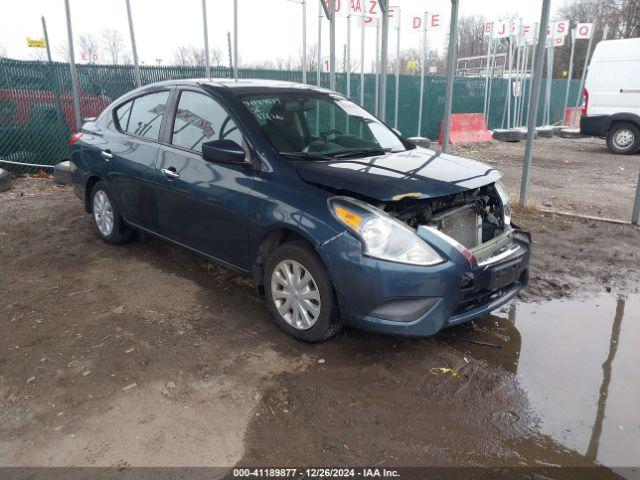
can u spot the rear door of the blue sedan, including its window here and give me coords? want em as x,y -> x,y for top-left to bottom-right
108,89 -> 171,232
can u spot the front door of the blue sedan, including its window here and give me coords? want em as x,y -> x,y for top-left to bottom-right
157,88 -> 255,270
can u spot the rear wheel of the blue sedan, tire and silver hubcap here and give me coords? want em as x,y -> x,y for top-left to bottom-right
91,182 -> 133,245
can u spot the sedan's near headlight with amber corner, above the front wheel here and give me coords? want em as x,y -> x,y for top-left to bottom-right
329,197 -> 444,265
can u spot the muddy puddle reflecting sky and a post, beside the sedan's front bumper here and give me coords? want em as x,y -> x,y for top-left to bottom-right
443,294 -> 640,467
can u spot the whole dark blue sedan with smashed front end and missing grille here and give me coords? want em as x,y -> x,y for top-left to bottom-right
71,80 -> 530,341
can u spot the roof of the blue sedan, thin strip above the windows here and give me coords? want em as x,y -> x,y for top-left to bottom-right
139,78 -> 333,94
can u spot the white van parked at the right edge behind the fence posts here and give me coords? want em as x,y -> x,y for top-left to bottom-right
580,38 -> 640,155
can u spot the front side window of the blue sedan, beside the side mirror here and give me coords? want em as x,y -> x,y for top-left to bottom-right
171,91 -> 242,152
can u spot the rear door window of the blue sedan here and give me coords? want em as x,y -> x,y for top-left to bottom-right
116,91 -> 169,140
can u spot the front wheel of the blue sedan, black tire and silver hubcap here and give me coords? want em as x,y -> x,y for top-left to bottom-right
264,242 -> 342,342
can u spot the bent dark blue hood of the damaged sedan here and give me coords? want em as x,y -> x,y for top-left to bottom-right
295,147 -> 502,201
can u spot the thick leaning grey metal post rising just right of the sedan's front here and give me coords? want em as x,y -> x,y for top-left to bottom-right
520,0 -> 551,205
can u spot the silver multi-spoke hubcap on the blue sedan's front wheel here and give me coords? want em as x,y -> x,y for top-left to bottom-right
271,260 -> 321,330
